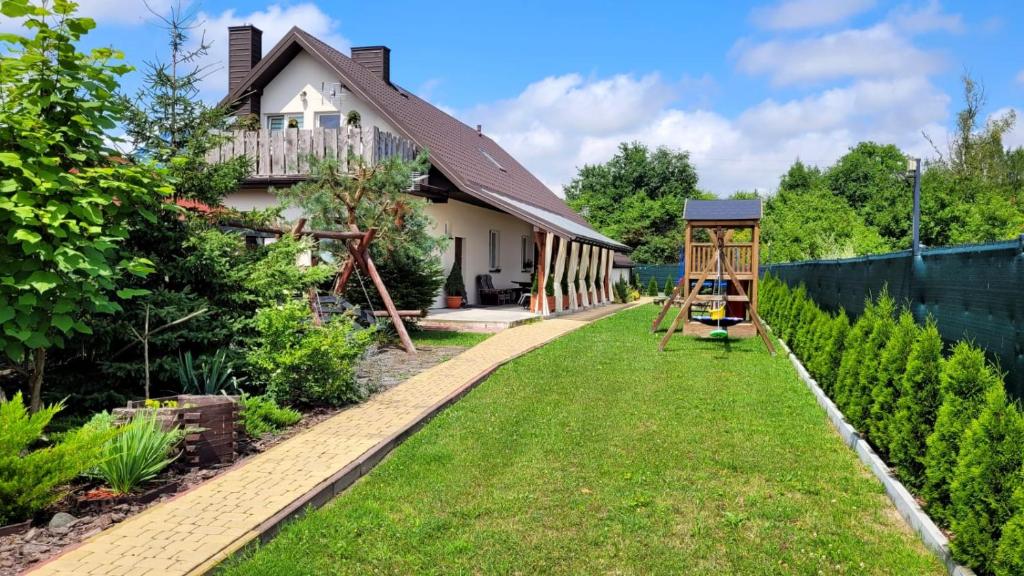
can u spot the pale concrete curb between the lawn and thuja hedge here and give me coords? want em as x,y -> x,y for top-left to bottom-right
778,340 -> 976,576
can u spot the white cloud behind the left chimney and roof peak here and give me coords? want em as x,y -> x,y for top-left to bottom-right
198,2 -> 350,101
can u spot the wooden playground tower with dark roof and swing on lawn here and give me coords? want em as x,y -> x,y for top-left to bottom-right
651,200 -> 775,355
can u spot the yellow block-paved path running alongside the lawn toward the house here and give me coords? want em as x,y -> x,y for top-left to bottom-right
30,299 -> 647,576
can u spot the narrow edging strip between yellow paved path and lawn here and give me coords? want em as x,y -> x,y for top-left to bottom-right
188,300 -> 638,576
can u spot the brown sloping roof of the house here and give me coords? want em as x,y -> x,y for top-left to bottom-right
223,28 -> 628,250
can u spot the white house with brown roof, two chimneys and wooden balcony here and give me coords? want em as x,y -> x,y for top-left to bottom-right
214,26 -> 630,315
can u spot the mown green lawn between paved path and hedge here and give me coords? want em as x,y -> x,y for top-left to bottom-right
226,305 -> 945,575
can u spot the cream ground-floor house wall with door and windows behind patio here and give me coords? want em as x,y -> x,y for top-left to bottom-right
426,200 -> 534,307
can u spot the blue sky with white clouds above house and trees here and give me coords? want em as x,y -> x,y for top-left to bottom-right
0,0 -> 1024,195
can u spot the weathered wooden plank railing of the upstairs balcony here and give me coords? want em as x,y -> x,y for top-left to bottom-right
206,126 -> 420,178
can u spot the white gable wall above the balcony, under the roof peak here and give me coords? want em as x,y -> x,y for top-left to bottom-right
260,51 -> 398,134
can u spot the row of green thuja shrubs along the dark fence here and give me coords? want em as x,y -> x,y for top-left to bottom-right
759,276 -> 1024,576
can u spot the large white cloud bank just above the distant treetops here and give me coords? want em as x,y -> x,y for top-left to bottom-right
460,69 -> 949,196
